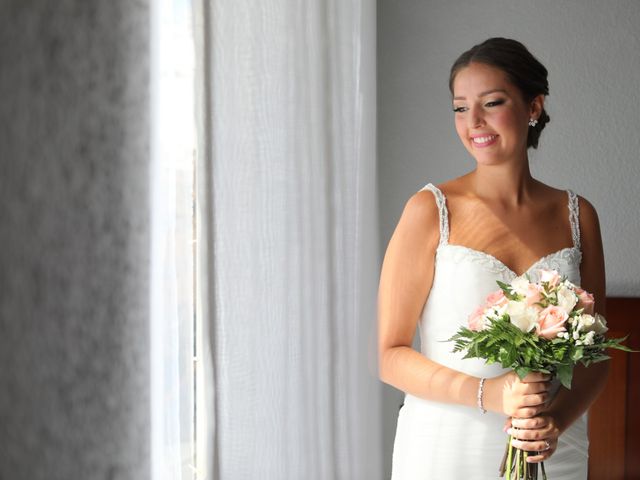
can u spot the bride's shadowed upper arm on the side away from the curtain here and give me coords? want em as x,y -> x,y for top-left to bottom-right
578,197 -> 606,315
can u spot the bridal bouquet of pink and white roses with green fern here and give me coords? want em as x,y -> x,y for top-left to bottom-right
449,270 -> 632,480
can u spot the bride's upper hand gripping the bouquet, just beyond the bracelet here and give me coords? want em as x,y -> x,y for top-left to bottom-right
484,372 -> 551,418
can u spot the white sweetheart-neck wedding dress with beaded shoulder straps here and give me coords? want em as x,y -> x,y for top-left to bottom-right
391,183 -> 588,480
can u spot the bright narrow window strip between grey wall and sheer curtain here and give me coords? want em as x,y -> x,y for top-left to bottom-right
151,0 -> 207,480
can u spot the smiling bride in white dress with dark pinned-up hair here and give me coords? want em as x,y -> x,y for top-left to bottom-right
378,38 -> 608,480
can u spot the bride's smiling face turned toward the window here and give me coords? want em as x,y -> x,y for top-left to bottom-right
453,62 -> 543,165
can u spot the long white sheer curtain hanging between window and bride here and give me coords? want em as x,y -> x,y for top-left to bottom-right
200,0 -> 382,480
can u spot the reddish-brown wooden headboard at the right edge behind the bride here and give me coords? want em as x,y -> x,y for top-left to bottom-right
589,297 -> 640,480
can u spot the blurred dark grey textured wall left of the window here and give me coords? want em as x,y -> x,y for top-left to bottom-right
0,0 -> 149,480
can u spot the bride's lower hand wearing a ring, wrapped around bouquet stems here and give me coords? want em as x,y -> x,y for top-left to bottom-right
505,415 -> 560,463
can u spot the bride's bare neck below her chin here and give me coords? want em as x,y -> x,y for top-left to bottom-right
471,156 -> 534,207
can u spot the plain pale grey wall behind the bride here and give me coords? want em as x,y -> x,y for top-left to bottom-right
378,0 -> 640,476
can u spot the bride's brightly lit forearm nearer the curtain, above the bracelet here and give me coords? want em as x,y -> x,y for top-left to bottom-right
380,346 -> 478,407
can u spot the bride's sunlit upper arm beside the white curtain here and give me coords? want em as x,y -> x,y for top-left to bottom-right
378,191 -> 440,358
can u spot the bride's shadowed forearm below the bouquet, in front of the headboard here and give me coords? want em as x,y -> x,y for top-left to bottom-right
547,361 -> 609,433
